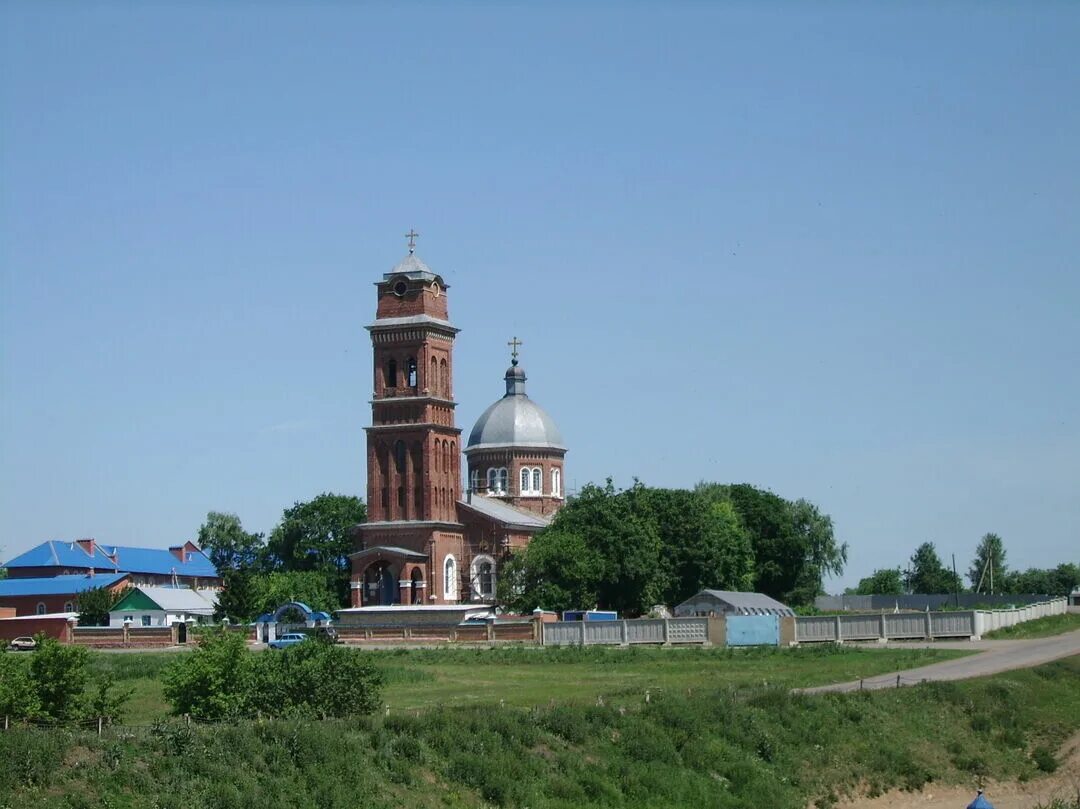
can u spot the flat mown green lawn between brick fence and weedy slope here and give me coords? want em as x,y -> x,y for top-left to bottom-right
91,646 -> 968,724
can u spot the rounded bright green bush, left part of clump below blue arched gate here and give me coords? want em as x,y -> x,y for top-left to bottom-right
162,629 -> 254,719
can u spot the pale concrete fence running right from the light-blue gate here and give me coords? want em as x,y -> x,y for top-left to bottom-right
795,598 -> 1068,644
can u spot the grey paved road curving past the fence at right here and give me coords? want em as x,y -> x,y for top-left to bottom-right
799,631 -> 1080,693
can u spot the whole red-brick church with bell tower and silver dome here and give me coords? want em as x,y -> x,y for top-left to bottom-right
351,238 -> 566,607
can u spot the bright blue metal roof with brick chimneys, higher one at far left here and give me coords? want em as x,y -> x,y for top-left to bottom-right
4,539 -> 217,577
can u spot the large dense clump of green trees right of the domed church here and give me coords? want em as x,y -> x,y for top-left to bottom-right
500,481 -> 829,615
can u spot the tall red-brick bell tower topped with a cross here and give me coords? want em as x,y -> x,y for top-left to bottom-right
351,231 -> 463,607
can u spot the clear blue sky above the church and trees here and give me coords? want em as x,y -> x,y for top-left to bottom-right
0,1 -> 1080,591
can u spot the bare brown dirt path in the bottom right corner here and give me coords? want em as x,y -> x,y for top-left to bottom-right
837,732 -> 1080,809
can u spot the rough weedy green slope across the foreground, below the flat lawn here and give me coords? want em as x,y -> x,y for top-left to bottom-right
0,650 -> 1080,809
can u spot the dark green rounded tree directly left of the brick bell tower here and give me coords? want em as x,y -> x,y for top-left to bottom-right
267,494 -> 367,607
